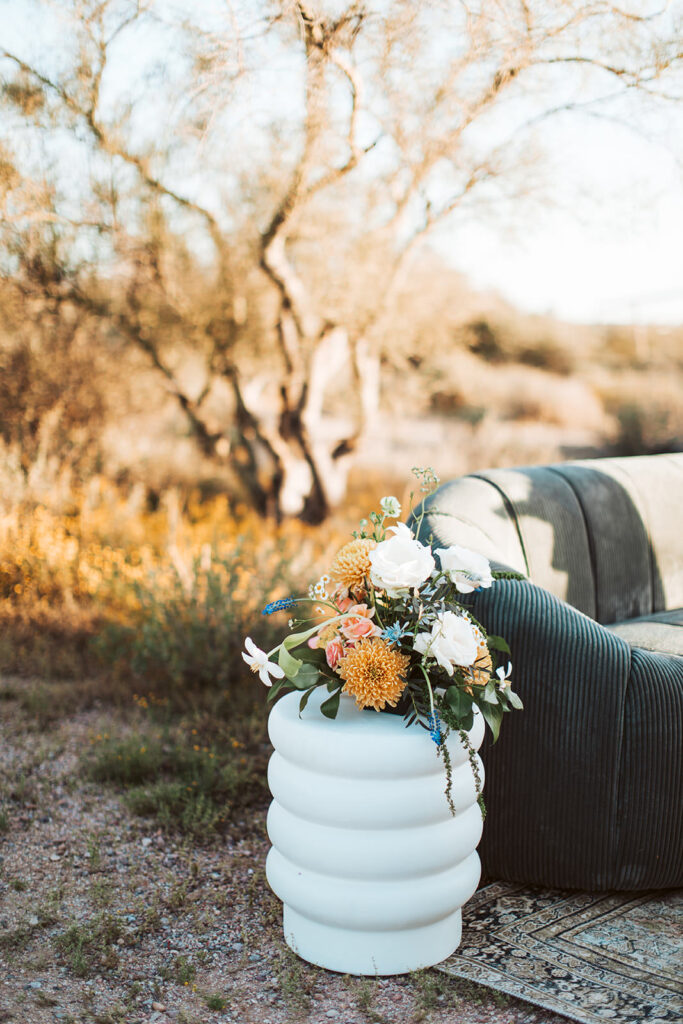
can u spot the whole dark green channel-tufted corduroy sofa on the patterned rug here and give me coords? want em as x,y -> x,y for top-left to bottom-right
413,454 -> 683,890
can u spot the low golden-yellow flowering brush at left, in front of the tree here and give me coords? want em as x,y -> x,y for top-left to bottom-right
0,481 -> 329,699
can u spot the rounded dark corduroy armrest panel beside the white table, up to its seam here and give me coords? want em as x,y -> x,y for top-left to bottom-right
471,580 -> 631,889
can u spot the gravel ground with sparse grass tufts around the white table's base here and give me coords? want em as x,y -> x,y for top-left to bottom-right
0,681 -> 565,1024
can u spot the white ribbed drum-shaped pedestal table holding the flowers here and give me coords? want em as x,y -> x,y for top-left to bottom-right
266,687 -> 484,975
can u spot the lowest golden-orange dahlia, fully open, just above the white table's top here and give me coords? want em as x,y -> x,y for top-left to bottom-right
337,637 -> 411,711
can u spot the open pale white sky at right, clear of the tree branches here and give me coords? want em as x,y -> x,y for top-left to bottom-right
437,111 -> 683,325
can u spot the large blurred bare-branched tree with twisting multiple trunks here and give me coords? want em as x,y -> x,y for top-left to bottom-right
0,0 -> 683,521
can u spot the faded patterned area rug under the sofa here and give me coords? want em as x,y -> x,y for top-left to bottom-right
439,882 -> 683,1024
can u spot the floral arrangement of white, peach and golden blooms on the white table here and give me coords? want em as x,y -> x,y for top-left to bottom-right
243,469 -> 522,813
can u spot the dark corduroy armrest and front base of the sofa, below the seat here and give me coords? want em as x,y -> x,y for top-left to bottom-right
468,580 -> 683,890
